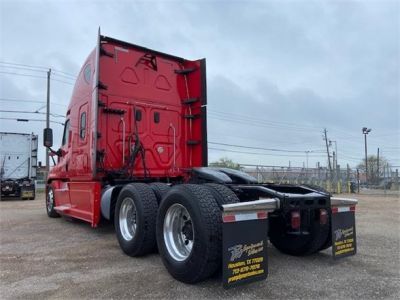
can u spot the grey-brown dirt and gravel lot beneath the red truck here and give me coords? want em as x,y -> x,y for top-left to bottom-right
0,195 -> 400,299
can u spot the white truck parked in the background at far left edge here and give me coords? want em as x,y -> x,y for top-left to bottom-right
0,132 -> 38,200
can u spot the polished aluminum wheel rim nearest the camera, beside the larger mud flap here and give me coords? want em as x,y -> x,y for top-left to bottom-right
163,203 -> 194,261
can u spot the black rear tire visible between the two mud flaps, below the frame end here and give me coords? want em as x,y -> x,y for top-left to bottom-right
269,210 -> 330,256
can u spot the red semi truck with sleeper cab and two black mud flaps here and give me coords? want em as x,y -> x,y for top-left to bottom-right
44,33 -> 356,287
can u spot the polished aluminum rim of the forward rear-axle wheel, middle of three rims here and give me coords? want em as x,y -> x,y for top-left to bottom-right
119,197 -> 137,241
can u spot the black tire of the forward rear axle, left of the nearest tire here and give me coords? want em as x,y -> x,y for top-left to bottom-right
114,183 -> 158,256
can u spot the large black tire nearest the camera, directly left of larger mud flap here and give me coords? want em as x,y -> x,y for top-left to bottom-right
157,184 -> 222,283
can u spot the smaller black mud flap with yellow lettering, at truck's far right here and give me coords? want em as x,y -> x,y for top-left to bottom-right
331,206 -> 357,259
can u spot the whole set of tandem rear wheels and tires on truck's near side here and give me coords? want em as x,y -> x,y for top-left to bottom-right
114,183 -> 239,283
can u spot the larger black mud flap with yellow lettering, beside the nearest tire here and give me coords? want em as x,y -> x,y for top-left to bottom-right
222,211 -> 268,288
